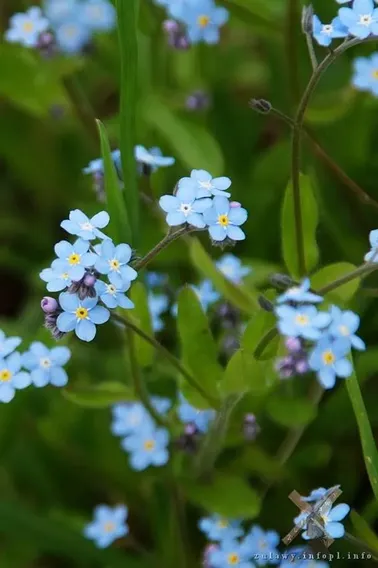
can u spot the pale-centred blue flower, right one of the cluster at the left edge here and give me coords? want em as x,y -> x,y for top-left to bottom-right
22,341 -> 71,387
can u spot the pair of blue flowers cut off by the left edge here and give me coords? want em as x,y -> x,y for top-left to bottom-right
0,330 -> 71,402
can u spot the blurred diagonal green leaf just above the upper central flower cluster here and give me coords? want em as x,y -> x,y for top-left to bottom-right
142,96 -> 224,176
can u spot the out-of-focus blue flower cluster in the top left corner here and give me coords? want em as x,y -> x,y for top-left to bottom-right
5,0 -> 116,53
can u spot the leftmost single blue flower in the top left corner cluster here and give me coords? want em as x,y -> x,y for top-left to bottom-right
5,6 -> 49,47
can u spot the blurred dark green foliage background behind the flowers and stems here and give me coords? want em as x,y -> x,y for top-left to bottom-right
0,0 -> 378,568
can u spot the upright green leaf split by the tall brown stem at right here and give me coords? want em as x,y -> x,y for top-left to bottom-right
281,174 -> 319,278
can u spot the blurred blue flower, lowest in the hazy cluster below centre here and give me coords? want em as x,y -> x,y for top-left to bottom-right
121,422 -> 169,471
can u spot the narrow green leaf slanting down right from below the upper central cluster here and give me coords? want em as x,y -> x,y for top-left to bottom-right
189,238 -> 258,314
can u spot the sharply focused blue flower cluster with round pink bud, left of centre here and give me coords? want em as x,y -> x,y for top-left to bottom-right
40,209 -> 137,341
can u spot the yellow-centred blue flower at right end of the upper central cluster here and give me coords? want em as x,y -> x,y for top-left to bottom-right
203,196 -> 248,241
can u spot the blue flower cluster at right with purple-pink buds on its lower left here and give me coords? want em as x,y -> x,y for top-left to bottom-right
275,279 -> 365,389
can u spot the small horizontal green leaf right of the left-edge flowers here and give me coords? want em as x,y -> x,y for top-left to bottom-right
62,382 -> 135,408
